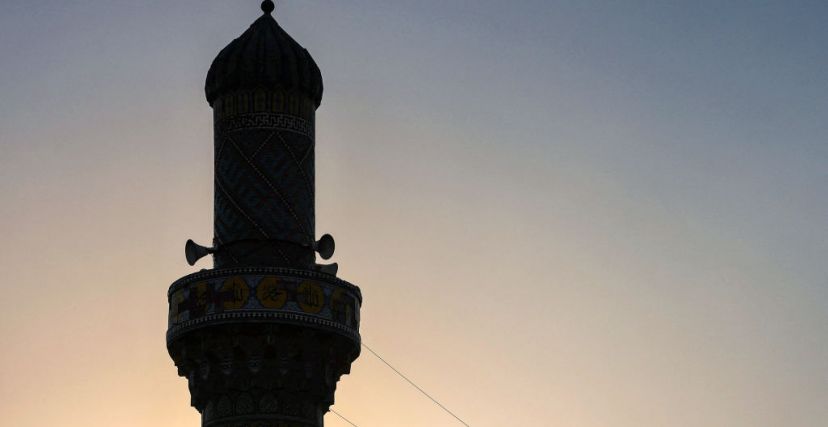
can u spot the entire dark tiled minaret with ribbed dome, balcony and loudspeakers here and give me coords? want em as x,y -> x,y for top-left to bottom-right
167,0 -> 362,427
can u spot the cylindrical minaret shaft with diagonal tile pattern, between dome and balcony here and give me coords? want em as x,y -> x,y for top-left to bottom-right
214,112 -> 315,267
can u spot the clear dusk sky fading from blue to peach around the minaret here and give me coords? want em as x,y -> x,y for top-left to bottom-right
0,0 -> 828,427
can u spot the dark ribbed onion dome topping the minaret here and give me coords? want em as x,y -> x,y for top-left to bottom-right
205,11 -> 322,107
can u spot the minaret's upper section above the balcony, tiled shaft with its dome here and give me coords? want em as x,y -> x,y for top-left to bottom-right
206,0 -> 322,268
